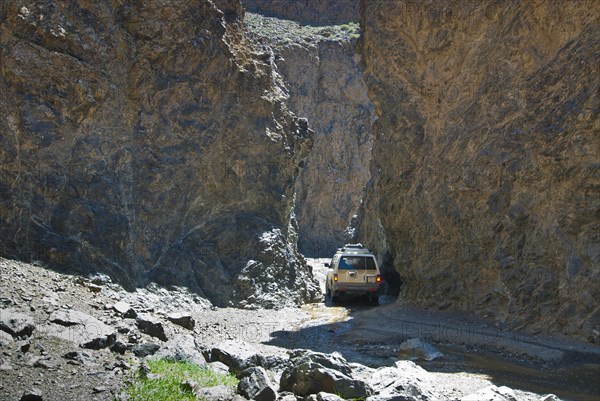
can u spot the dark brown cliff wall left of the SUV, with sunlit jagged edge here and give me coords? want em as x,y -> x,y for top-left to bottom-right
0,0 -> 317,305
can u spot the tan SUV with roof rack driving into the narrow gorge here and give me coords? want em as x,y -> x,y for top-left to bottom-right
325,244 -> 381,303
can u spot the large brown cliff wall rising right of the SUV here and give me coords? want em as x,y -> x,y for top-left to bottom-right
360,0 -> 600,341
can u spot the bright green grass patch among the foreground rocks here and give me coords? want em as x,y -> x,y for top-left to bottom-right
126,359 -> 238,401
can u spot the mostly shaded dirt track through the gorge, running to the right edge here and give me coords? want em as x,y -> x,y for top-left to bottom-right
298,259 -> 600,401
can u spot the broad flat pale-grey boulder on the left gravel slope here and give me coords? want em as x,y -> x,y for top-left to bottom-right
47,310 -> 117,349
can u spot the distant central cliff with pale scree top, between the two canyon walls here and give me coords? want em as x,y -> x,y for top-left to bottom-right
244,13 -> 373,257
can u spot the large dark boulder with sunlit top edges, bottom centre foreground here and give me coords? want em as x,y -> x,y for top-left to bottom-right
280,350 -> 372,398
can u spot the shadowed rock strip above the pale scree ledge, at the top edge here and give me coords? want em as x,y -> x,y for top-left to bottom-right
241,0 -> 360,25
